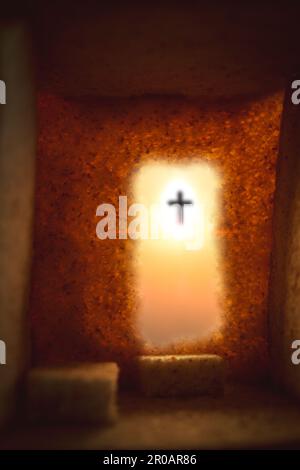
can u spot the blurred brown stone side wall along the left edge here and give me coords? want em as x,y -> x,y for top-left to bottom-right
0,24 -> 35,426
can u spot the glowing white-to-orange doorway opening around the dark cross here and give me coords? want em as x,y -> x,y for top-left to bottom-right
135,163 -> 221,346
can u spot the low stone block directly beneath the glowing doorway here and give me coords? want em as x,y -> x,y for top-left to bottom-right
138,354 -> 225,397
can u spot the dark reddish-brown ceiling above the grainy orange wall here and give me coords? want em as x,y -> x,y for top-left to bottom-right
1,1 -> 300,99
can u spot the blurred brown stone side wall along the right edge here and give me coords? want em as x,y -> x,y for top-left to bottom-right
269,84 -> 300,397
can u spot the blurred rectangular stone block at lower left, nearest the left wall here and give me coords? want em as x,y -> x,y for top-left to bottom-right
27,363 -> 118,424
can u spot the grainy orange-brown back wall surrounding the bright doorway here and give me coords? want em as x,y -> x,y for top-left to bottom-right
31,93 -> 282,380
